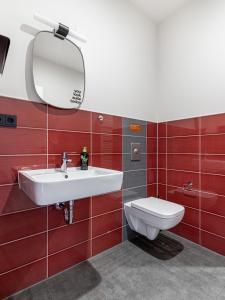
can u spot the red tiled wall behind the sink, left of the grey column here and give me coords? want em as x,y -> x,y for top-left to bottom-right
0,97 -> 125,299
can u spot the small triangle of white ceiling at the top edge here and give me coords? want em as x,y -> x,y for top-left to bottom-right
130,0 -> 190,22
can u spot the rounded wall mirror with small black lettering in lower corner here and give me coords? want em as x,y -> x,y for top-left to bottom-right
33,31 -> 85,109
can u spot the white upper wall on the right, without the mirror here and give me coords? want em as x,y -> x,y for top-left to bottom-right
158,0 -> 225,121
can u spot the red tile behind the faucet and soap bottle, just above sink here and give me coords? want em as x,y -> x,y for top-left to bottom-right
48,154 -> 81,168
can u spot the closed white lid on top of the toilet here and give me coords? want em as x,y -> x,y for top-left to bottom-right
131,197 -> 184,219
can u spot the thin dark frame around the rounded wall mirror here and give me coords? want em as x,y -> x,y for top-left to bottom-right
31,30 -> 86,110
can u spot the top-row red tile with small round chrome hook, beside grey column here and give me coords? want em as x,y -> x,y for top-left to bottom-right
92,113 -> 122,135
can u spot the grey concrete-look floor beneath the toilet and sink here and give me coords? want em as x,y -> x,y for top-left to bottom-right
9,233 -> 225,300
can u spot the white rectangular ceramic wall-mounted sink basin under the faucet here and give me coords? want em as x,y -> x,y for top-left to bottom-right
19,167 -> 123,206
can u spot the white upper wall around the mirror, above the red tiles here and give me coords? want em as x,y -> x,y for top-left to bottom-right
0,0 -> 156,121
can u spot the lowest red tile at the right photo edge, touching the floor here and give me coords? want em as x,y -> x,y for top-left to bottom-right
201,231 -> 225,255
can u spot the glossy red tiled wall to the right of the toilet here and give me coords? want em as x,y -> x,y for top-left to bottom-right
158,114 -> 225,255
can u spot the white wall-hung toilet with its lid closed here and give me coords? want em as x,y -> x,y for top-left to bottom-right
124,197 -> 185,240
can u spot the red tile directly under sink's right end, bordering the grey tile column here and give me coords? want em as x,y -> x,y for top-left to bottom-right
92,191 -> 122,216
